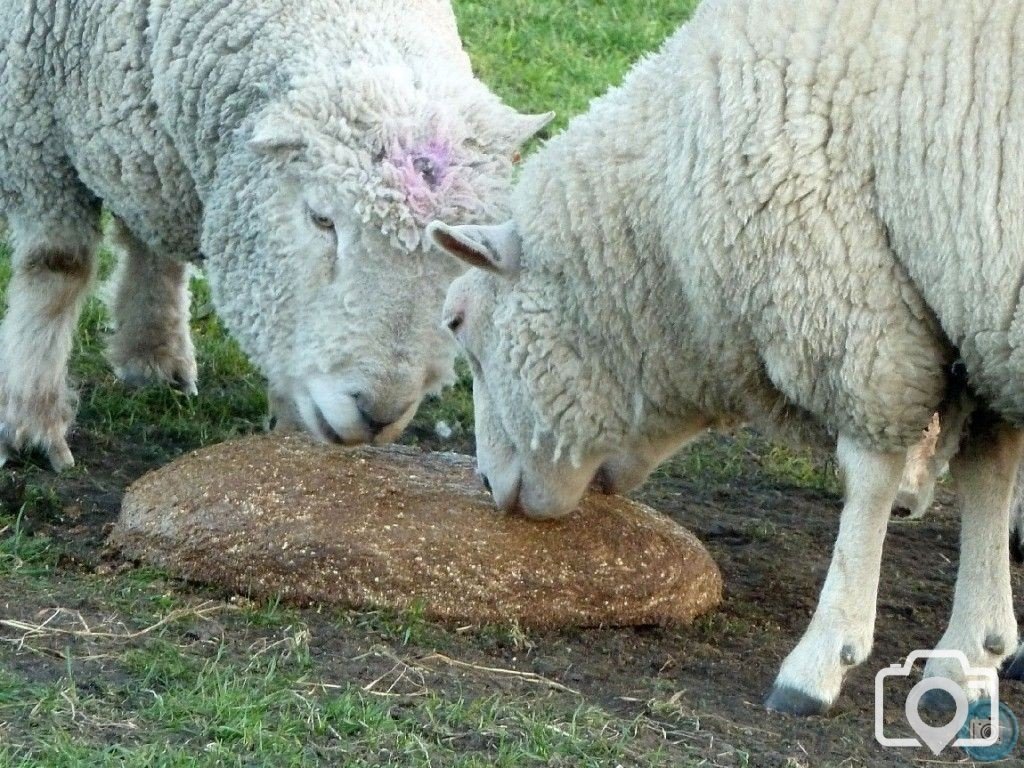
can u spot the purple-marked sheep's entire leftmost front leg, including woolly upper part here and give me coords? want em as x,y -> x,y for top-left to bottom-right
0,175 -> 99,471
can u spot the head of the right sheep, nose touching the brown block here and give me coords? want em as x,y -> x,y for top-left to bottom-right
427,222 -> 708,517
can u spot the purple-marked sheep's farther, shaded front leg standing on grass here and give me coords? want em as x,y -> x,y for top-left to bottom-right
106,218 -> 197,394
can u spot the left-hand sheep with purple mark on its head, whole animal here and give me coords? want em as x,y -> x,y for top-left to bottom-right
0,0 -> 551,469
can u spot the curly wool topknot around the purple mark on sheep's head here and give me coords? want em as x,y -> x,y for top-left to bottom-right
264,61 -> 513,251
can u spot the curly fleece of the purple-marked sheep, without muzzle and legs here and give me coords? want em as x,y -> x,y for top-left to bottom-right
0,0 -> 524,388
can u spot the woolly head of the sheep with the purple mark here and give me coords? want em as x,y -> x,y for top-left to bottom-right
204,65 -> 550,444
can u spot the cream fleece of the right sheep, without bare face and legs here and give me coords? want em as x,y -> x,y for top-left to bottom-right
489,0 -> 1024,462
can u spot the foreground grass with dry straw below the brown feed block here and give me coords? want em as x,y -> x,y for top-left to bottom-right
0,501 -> 700,768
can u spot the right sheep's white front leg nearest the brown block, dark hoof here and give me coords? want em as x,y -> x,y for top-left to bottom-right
766,436 -> 905,715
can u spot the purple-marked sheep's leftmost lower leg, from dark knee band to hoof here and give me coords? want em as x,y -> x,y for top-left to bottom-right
0,237 -> 95,471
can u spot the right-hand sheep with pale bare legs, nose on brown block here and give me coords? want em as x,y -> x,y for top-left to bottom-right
427,0 -> 1024,715
